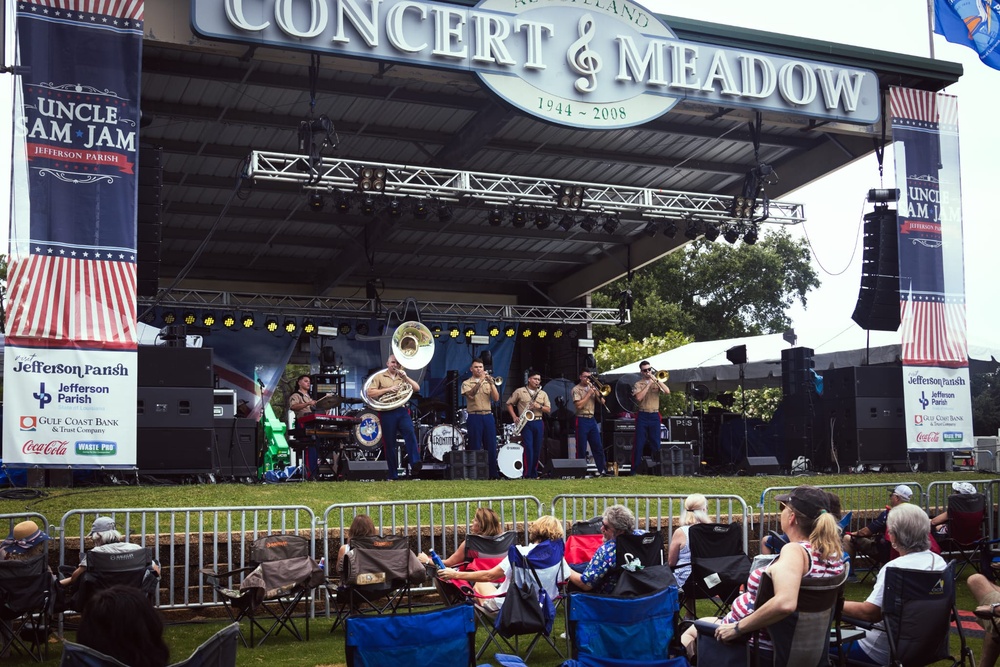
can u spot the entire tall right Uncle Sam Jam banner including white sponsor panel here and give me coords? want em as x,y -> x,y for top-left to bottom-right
889,87 -> 972,450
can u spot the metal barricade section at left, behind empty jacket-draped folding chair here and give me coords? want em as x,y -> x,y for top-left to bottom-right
58,505 -> 317,609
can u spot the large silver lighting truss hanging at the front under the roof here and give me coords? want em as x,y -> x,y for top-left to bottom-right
244,151 -> 805,225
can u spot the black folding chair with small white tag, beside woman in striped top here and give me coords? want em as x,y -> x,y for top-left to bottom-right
682,523 -> 750,617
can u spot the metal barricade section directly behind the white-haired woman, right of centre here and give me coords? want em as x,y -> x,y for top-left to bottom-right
551,494 -> 753,550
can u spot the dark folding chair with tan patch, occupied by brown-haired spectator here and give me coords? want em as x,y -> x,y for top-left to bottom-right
330,535 -> 426,632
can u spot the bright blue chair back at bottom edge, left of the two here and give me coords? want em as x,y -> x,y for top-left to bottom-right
344,605 -> 476,667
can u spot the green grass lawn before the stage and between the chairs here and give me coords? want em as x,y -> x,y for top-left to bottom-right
0,473 -> 983,667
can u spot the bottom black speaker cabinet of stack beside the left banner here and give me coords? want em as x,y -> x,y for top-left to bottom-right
136,428 -> 215,475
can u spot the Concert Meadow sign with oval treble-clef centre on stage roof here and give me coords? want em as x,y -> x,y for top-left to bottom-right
191,0 -> 880,130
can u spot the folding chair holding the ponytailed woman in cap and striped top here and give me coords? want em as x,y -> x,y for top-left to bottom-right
695,569 -> 847,667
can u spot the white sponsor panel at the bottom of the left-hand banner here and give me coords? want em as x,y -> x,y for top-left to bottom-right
3,338 -> 137,468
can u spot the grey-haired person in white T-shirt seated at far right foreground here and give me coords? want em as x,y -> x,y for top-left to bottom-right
843,503 -> 946,665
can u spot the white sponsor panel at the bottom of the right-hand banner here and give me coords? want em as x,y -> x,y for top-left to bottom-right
903,367 -> 975,450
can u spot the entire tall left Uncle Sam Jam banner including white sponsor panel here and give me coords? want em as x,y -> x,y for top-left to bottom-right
3,0 -> 143,467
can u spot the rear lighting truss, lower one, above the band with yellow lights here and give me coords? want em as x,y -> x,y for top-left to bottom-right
139,289 -> 621,326
